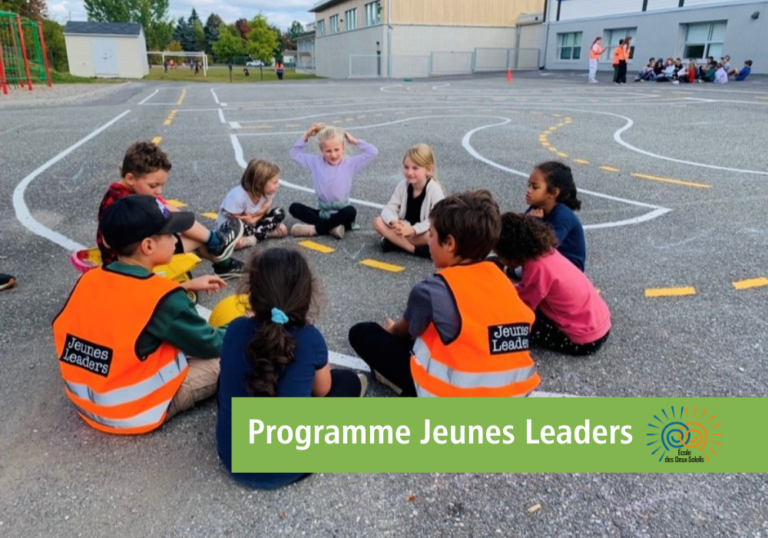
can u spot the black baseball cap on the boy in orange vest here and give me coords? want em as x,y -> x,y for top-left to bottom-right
100,194 -> 195,248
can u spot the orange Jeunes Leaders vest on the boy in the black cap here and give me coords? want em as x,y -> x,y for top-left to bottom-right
53,268 -> 187,434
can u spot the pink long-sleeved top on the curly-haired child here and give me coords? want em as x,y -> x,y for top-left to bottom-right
515,250 -> 611,344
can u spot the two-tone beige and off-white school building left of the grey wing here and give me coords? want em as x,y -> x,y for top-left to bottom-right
310,0 -> 544,78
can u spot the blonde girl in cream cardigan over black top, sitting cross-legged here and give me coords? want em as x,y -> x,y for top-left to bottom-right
373,144 -> 445,258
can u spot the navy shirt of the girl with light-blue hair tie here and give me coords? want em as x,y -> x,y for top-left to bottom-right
216,317 -> 328,489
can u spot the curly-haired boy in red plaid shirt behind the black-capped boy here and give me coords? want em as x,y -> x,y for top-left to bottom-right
96,142 -> 243,279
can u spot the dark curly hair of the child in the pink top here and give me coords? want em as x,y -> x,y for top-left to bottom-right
495,212 -> 557,265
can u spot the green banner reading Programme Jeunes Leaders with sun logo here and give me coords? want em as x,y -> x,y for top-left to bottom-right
232,398 -> 768,473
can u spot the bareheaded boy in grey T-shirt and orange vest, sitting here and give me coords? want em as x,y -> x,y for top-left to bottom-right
349,190 -> 541,397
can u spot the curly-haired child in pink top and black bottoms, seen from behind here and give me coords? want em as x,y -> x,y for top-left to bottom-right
495,213 -> 611,355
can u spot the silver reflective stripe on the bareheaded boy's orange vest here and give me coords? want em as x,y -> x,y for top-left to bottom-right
413,338 -> 536,390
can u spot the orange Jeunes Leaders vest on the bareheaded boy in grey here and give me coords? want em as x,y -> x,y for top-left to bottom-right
411,261 -> 541,397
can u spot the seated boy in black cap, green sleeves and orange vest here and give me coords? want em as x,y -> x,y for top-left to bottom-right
53,194 -> 226,434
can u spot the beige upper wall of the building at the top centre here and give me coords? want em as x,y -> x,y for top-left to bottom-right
396,0 -> 544,26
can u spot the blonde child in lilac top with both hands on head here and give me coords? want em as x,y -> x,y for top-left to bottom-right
288,123 -> 379,239
